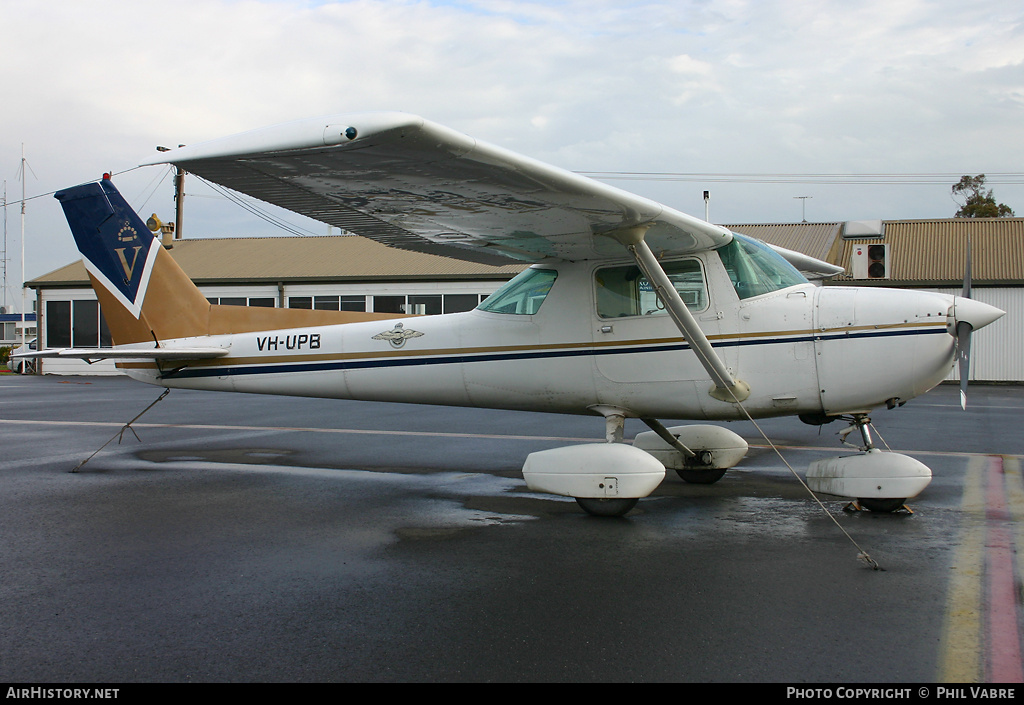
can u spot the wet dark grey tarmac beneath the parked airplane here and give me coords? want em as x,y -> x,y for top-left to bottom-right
0,376 -> 1024,683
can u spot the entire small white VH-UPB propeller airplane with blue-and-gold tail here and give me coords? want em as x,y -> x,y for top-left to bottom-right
34,113 -> 1004,515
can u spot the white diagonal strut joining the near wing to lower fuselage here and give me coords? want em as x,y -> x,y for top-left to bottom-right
610,225 -> 751,403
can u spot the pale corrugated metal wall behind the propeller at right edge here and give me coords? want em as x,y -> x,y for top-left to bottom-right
929,287 -> 1024,382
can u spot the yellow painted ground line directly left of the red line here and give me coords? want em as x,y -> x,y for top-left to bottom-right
937,457 -> 988,683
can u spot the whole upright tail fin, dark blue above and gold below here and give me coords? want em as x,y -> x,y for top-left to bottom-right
54,177 -> 210,345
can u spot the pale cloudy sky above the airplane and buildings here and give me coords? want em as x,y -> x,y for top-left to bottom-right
0,0 -> 1024,296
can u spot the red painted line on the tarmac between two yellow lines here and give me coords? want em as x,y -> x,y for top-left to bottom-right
986,456 -> 1024,682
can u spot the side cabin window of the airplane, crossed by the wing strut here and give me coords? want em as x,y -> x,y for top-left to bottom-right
594,259 -> 708,319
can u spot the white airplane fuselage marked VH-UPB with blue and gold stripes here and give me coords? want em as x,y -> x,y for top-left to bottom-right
130,251 -> 955,419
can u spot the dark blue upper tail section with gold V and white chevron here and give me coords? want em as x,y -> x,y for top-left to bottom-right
54,178 -> 161,319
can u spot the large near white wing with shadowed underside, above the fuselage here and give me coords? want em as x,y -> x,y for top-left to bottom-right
145,113 -> 732,264
